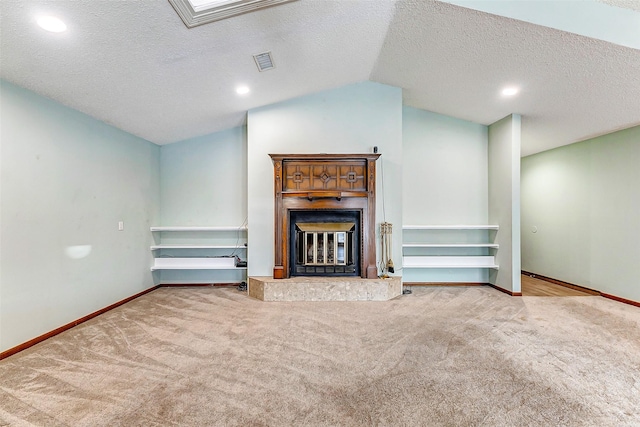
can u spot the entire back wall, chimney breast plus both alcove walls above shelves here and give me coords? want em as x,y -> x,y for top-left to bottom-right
161,83 -> 488,282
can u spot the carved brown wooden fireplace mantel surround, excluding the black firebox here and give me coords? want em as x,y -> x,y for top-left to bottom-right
269,154 -> 380,279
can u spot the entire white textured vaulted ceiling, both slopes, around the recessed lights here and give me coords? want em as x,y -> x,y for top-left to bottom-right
0,0 -> 640,155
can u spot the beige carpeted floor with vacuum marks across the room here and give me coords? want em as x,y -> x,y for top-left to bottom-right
0,287 -> 640,427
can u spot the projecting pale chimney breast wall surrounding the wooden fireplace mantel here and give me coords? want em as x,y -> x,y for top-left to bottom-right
247,82 -> 403,276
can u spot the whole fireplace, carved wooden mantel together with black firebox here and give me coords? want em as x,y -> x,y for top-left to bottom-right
270,154 -> 380,279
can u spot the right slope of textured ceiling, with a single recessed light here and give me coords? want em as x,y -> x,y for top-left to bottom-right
372,1 -> 640,154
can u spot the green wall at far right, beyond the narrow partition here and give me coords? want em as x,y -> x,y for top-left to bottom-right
522,126 -> 640,301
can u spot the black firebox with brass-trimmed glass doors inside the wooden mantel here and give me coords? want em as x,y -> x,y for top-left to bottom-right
288,210 -> 360,276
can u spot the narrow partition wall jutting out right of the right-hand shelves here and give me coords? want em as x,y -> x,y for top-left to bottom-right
489,114 -> 522,293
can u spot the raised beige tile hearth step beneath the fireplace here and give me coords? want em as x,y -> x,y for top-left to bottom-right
249,277 -> 402,301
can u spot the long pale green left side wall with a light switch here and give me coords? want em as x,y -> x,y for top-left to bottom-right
0,82 -> 160,351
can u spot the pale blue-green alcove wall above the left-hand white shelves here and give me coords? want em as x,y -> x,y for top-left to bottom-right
157,126 -> 247,226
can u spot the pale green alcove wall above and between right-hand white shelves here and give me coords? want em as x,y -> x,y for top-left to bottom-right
402,106 -> 492,283
